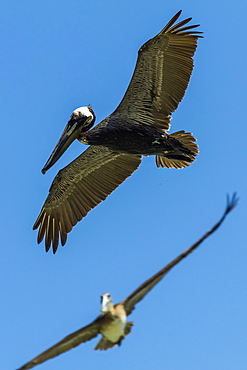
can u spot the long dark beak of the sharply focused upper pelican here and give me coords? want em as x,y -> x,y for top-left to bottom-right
41,114 -> 90,174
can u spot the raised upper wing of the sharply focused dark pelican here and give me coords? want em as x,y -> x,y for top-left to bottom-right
112,11 -> 202,130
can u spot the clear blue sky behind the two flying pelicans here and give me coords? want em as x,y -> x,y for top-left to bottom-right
0,0 -> 247,370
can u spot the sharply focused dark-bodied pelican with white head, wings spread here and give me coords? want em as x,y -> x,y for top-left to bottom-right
33,10 -> 202,253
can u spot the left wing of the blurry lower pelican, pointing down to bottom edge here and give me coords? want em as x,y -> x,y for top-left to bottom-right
18,316 -> 101,370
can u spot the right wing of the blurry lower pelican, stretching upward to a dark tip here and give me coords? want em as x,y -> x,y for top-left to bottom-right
121,193 -> 238,315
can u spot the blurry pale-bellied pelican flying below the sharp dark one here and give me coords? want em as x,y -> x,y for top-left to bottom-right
18,193 -> 238,370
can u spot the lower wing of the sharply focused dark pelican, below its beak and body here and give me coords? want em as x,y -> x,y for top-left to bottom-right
33,146 -> 141,253
